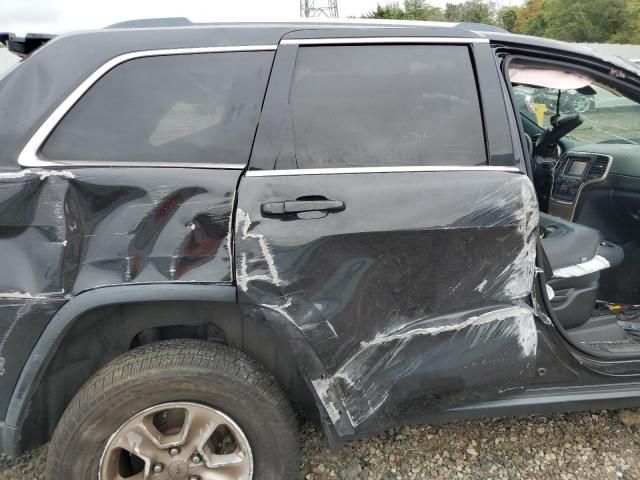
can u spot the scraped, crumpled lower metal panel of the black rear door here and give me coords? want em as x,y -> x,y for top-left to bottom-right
236,173 -> 538,429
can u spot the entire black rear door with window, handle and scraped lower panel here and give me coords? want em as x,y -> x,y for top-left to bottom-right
235,37 -> 538,435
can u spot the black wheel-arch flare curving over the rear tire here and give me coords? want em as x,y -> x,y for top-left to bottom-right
0,283 -> 236,455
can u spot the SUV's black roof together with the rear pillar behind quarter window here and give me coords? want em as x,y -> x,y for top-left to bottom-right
0,19 -> 640,170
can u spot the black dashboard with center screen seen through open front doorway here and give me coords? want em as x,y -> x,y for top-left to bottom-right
541,142 -> 640,304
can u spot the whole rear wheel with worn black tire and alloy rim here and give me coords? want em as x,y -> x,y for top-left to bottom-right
47,340 -> 299,480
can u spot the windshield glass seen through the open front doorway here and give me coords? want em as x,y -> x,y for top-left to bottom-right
513,82 -> 640,144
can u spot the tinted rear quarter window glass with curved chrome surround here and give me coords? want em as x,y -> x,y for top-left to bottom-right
41,52 -> 273,164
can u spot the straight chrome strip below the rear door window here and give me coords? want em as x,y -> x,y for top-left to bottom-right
246,165 -> 523,177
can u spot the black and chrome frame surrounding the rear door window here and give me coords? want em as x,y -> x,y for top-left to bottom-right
247,36 -> 496,175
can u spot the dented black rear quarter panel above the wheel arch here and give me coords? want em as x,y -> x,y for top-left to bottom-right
0,168 -> 240,414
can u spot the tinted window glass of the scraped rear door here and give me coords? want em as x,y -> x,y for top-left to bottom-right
289,45 -> 486,168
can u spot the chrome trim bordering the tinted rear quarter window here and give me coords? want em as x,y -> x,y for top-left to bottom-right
18,45 -> 277,169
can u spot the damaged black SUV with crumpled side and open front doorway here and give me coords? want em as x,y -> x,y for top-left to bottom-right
0,22 -> 640,480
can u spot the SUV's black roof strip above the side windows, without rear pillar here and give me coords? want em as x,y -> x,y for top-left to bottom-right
0,17 -> 636,66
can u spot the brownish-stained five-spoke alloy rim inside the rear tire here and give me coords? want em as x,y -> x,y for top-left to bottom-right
99,402 -> 253,480
